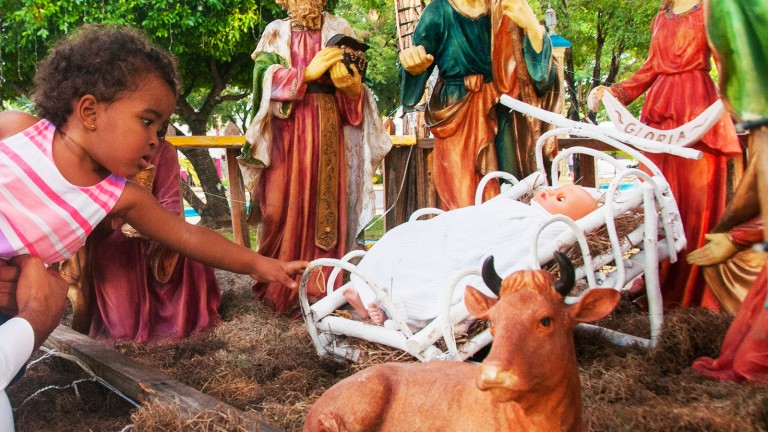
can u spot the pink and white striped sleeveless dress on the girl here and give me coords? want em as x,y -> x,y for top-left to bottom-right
0,120 -> 126,264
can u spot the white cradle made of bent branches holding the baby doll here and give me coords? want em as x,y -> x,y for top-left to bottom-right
299,98 -> 696,361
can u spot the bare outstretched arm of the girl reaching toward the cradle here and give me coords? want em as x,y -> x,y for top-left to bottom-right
111,181 -> 307,288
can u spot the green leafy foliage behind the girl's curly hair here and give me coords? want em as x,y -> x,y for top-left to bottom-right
0,0 -> 282,113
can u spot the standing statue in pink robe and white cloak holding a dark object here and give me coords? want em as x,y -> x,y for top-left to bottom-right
240,0 -> 392,314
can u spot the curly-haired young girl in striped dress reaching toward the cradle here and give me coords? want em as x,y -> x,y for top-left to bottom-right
0,25 -> 306,287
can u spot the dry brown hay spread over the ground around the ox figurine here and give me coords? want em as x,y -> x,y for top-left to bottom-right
9,272 -> 768,432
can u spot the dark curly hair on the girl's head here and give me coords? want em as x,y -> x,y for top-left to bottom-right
32,24 -> 180,127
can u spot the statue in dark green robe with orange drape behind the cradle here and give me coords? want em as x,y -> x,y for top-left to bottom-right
400,0 -> 560,209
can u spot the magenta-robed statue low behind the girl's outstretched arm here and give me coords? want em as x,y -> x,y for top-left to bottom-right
83,140 -> 221,343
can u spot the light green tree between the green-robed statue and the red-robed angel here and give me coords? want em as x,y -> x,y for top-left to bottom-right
552,0 -> 659,120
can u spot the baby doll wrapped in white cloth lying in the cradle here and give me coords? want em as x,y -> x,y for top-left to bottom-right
342,184 -> 598,328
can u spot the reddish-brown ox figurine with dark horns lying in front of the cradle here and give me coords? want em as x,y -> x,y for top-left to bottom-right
304,252 -> 619,432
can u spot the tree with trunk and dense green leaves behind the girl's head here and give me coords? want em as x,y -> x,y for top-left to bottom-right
0,0 -> 282,226
